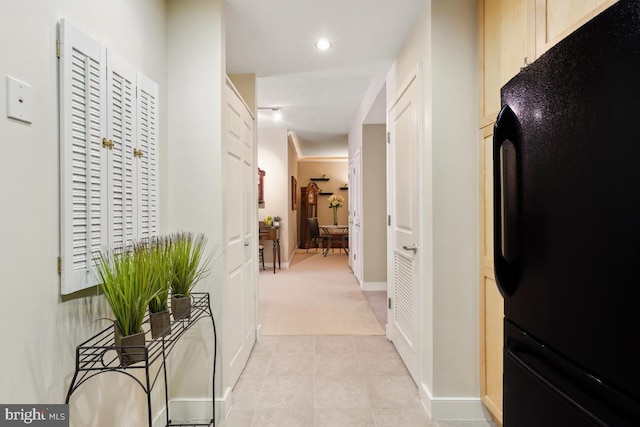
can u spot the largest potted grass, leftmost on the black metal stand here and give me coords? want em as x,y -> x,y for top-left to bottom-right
96,248 -> 156,366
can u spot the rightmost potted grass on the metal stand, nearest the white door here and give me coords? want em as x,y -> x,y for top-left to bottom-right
169,232 -> 214,320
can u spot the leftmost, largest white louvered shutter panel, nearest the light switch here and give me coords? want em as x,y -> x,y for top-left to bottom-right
59,20 -> 108,294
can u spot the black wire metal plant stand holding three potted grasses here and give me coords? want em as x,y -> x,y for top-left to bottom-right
65,292 -> 218,427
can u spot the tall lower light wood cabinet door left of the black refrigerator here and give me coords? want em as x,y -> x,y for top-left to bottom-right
479,125 -> 504,424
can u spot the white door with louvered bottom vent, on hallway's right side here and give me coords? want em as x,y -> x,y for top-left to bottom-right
387,74 -> 420,382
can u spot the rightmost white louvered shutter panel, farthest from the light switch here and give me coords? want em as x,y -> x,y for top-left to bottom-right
135,73 -> 158,239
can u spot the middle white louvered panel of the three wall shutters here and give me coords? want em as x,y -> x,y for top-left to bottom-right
107,55 -> 137,251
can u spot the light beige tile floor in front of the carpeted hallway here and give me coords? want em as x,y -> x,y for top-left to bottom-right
218,336 -> 495,427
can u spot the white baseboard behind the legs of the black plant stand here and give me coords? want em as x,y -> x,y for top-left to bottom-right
166,387 -> 232,427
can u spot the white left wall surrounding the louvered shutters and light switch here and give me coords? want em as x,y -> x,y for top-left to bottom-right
0,0 -> 167,427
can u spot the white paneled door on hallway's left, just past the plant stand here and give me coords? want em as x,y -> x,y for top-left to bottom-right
222,82 -> 258,384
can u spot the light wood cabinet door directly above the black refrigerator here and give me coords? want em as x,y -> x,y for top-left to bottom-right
535,0 -> 617,58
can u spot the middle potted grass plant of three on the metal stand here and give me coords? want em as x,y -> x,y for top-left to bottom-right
145,237 -> 171,338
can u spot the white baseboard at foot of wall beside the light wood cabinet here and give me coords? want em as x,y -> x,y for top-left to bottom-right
420,383 -> 491,427
